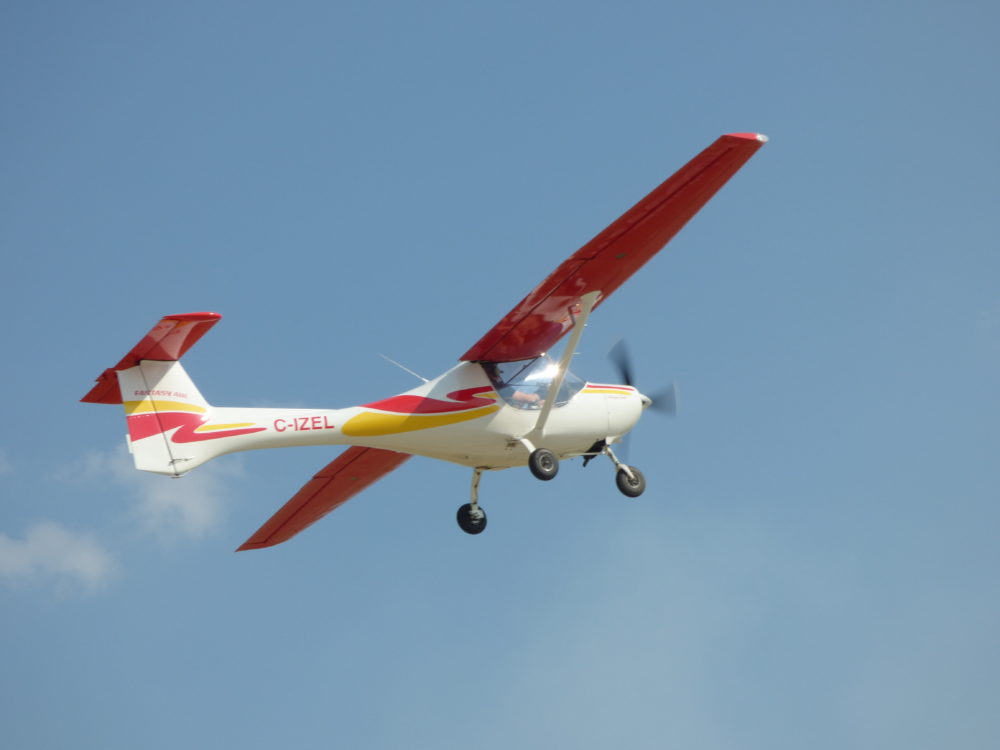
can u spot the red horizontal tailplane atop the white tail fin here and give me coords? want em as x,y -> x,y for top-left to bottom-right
80,313 -> 222,404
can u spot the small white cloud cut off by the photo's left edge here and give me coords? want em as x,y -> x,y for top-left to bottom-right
0,521 -> 118,592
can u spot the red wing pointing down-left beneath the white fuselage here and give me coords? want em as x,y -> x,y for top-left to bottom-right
239,448 -> 410,550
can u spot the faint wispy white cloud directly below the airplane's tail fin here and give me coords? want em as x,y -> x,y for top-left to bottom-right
76,447 -> 243,541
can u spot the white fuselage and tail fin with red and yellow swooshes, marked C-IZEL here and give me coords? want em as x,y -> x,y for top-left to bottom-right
120,361 -> 643,475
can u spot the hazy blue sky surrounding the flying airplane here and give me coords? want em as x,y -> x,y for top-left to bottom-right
0,0 -> 1000,750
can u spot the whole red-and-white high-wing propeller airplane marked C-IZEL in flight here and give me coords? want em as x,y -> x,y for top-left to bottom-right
81,133 -> 767,550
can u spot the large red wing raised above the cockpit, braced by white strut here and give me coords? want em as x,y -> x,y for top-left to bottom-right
461,133 -> 767,362
